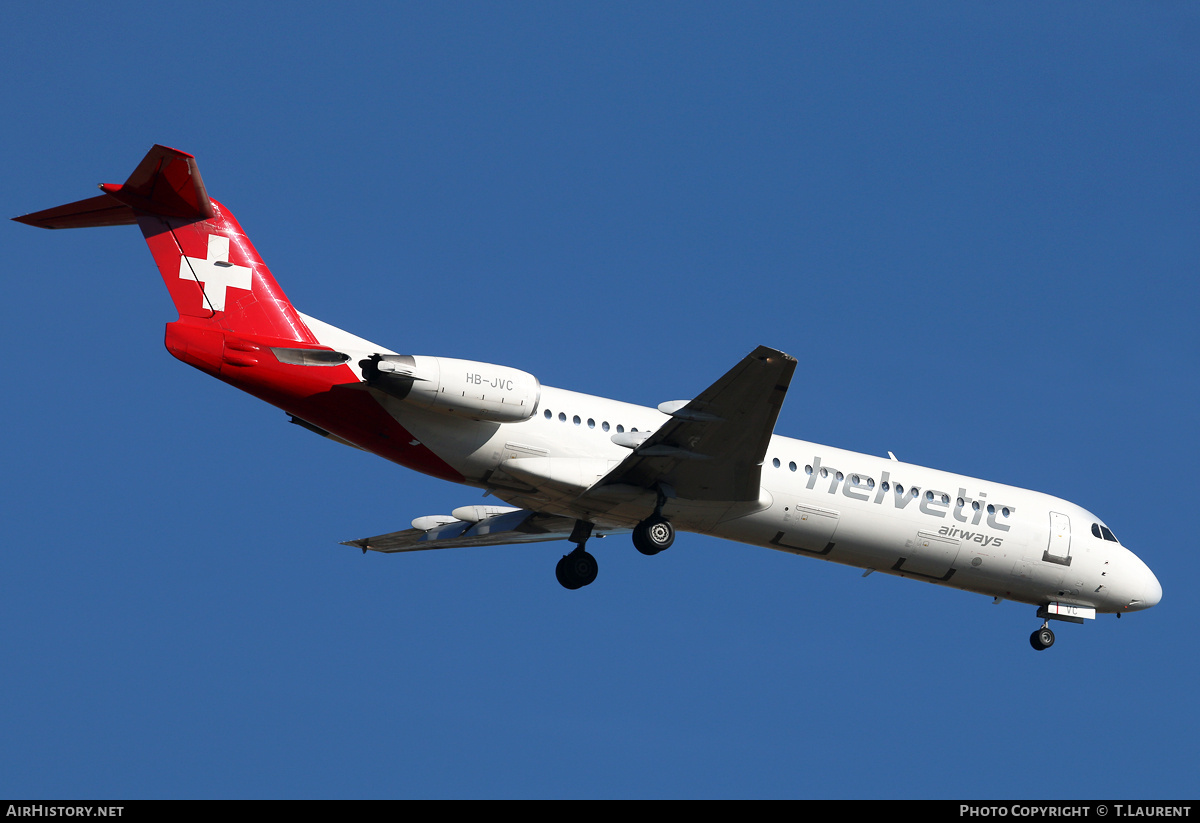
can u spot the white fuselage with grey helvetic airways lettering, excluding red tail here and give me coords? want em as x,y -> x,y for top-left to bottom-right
350,364 -> 1160,612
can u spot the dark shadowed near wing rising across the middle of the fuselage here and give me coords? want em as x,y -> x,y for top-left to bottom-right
588,346 -> 796,500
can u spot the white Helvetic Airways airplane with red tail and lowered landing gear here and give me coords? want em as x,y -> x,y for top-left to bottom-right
13,145 -> 1163,650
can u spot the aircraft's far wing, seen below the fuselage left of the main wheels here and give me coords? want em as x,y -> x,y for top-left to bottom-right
342,509 -> 630,553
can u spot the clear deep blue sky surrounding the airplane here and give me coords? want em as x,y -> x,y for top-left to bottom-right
0,2 -> 1200,799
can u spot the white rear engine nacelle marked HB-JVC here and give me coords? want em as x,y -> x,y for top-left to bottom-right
361,354 -> 541,423
